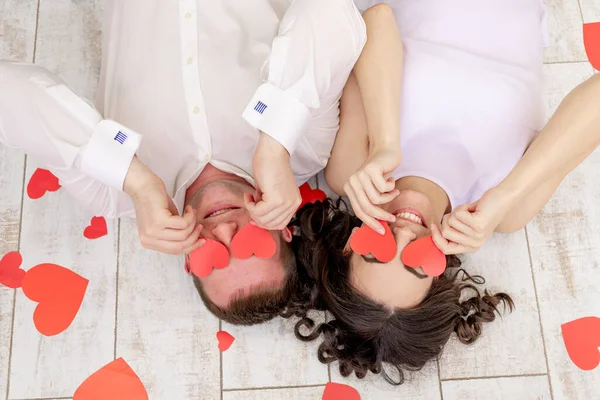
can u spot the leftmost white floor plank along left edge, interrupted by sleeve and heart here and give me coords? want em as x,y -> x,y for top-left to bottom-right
0,0 -> 37,398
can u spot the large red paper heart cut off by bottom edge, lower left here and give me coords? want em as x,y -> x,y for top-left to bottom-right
73,358 -> 148,400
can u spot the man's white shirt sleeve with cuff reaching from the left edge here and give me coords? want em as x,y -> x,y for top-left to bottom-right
0,62 -> 142,216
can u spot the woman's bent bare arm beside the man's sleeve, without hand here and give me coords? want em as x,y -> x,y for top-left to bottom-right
325,4 -> 403,191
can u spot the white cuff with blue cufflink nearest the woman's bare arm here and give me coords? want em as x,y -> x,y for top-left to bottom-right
242,83 -> 310,155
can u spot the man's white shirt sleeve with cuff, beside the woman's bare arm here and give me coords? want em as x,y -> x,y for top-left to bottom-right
243,0 -> 366,155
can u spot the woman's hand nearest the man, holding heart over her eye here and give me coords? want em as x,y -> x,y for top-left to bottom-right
344,145 -> 402,235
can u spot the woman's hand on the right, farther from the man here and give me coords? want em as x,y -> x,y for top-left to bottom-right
431,187 -> 511,254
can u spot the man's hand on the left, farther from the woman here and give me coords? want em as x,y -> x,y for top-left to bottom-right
123,157 -> 204,254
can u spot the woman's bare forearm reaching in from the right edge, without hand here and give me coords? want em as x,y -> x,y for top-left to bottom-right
496,74 -> 600,232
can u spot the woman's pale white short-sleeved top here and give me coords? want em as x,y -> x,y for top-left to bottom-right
357,0 -> 547,207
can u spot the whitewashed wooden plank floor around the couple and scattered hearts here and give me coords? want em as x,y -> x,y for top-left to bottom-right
0,0 -> 600,400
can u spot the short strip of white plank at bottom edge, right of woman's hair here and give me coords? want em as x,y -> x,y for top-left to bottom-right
442,375 -> 558,400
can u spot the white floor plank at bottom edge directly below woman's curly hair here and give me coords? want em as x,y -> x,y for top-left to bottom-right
331,361 -> 441,400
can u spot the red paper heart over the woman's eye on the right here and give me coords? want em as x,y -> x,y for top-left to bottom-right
402,236 -> 446,276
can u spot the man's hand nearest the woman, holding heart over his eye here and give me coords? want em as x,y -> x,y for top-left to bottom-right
244,132 -> 302,230
